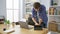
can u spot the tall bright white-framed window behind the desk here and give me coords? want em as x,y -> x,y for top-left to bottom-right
6,0 -> 19,22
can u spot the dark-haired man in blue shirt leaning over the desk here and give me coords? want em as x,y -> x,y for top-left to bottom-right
32,2 -> 48,28
